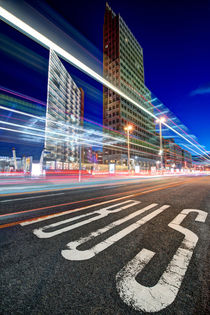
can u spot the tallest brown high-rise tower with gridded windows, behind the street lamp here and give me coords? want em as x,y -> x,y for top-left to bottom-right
103,4 -> 158,170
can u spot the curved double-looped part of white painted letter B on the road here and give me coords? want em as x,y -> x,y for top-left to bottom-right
33,200 -> 140,238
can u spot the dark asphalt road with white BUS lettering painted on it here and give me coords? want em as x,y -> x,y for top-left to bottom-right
0,176 -> 210,315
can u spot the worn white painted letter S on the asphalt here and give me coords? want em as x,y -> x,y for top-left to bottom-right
116,209 -> 207,312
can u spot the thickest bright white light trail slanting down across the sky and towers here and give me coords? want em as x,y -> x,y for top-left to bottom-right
0,6 -> 209,160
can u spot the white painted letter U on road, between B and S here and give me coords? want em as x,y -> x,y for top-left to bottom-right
61,203 -> 170,260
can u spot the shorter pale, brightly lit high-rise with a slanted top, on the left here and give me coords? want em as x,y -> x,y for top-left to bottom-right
44,50 -> 84,169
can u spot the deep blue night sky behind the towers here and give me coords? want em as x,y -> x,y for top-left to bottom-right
0,0 -> 210,155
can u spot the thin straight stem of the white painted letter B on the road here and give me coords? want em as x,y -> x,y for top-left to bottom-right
20,195 -> 134,226
